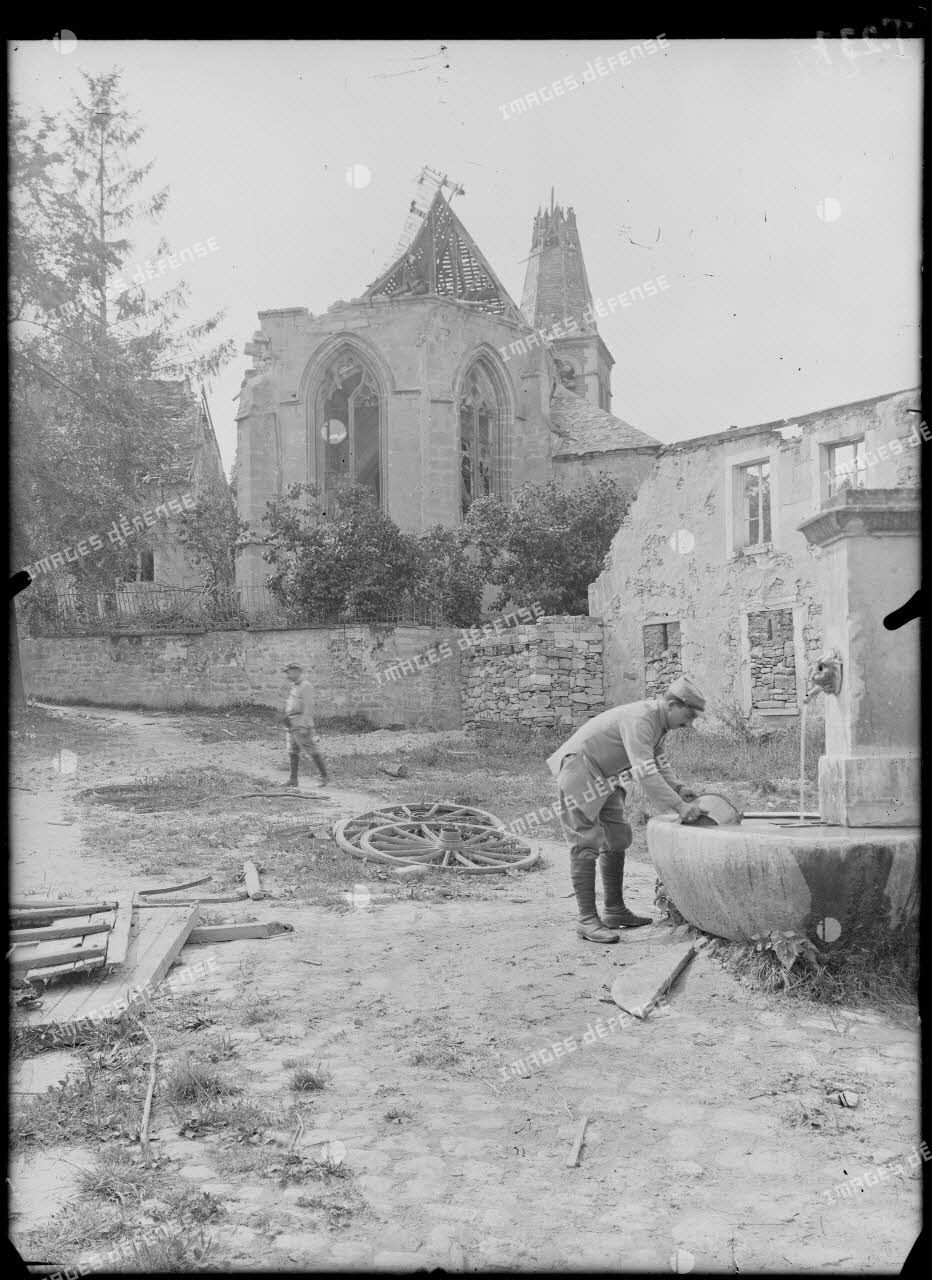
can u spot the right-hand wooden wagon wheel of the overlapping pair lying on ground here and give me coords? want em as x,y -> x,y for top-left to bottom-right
360,819 -> 540,876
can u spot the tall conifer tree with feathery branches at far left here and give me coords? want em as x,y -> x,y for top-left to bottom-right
9,72 -> 234,585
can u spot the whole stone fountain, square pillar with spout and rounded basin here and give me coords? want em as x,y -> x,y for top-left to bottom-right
647,489 -> 919,950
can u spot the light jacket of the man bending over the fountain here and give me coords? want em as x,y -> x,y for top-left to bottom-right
547,698 -> 686,818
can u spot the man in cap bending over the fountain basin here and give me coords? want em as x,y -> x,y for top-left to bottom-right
547,677 -> 705,942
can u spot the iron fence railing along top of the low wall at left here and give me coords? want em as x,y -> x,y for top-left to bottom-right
17,582 -> 443,636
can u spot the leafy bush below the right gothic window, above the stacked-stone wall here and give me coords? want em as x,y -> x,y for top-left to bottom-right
460,474 -> 630,613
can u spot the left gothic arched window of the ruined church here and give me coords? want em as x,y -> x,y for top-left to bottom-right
317,351 -> 382,502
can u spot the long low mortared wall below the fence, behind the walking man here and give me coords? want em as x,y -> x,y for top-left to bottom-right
20,626 -> 461,730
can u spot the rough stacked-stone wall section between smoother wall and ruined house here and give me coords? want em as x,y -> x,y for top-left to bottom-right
462,614 -> 606,728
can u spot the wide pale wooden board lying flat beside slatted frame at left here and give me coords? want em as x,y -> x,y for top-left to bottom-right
17,904 -> 197,1030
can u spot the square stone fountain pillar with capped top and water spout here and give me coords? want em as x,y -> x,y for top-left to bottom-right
799,489 -> 920,827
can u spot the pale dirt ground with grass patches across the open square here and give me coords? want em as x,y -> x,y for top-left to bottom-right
9,708 -> 922,1272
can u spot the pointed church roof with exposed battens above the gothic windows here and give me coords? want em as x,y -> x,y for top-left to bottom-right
364,189 -> 525,324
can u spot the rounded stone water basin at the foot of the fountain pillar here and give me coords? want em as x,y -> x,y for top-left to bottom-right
647,814 -> 919,947
